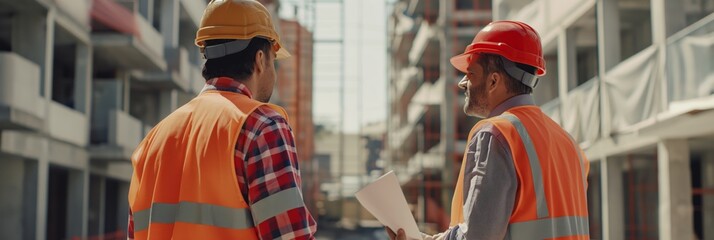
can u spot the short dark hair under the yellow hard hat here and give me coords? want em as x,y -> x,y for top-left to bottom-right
201,38 -> 272,81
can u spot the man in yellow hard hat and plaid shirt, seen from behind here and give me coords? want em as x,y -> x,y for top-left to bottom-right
129,0 -> 316,240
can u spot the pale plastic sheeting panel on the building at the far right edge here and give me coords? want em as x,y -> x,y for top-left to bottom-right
667,17 -> 714,102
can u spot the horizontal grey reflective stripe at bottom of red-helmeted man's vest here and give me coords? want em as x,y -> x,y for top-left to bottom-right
508,216 -> 590,239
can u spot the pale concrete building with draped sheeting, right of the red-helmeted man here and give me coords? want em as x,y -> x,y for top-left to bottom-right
494,0 -> 714,239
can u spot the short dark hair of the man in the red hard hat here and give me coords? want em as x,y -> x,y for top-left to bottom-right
478,53 -> 536,94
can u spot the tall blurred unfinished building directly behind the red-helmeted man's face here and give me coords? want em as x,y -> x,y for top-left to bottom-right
386,0 -> 491,232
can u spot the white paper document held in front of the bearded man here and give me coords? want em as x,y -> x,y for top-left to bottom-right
355,171 -> 422,239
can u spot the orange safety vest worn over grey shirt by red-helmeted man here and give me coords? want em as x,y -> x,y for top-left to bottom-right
451,106 -> 590,239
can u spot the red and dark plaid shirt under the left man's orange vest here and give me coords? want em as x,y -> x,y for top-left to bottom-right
128,78 -> 317,239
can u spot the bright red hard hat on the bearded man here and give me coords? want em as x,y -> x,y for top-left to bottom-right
451,21 -> 545,76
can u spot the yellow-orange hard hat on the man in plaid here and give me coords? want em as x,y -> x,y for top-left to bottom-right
196,0 -> 290,59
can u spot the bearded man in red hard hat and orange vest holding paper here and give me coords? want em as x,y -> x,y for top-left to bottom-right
387,21 -> 589,240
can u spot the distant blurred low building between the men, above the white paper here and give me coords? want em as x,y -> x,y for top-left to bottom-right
315,123 -> 386,230
